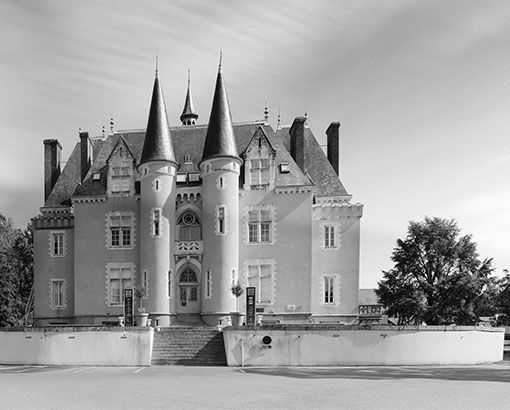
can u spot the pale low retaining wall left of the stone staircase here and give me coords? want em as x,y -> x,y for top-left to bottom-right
0,327 -> 154,366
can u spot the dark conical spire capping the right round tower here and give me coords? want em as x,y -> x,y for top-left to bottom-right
202,60 -> 240,161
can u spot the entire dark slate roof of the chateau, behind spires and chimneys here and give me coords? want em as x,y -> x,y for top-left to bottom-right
44,121 -> 347,207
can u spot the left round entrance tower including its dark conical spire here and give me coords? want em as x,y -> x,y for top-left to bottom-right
138,71 -> 178,326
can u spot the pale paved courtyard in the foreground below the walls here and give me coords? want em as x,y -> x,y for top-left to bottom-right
0,361 -> 510,410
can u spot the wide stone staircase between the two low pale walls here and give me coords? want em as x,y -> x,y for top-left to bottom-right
152,324 -> 227,366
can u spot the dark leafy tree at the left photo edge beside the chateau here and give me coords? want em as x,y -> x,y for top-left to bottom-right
0,214 -> 33,327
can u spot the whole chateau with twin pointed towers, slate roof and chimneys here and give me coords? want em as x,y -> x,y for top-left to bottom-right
33,64 -> 362,327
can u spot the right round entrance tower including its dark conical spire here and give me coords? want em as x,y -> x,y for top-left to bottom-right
199,65 -> 242,325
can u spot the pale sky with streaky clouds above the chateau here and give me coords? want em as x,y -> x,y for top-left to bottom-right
0,0 -> 510,288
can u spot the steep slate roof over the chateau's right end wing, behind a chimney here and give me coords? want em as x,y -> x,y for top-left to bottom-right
276,127 -> 349,197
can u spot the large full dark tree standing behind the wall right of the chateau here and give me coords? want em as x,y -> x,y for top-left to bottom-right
376,217 -> 495,325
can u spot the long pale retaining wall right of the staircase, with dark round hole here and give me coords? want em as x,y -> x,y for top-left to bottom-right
223,325 -> 504,366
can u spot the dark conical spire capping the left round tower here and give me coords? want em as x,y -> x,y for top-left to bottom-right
140,69 -> 177,165
